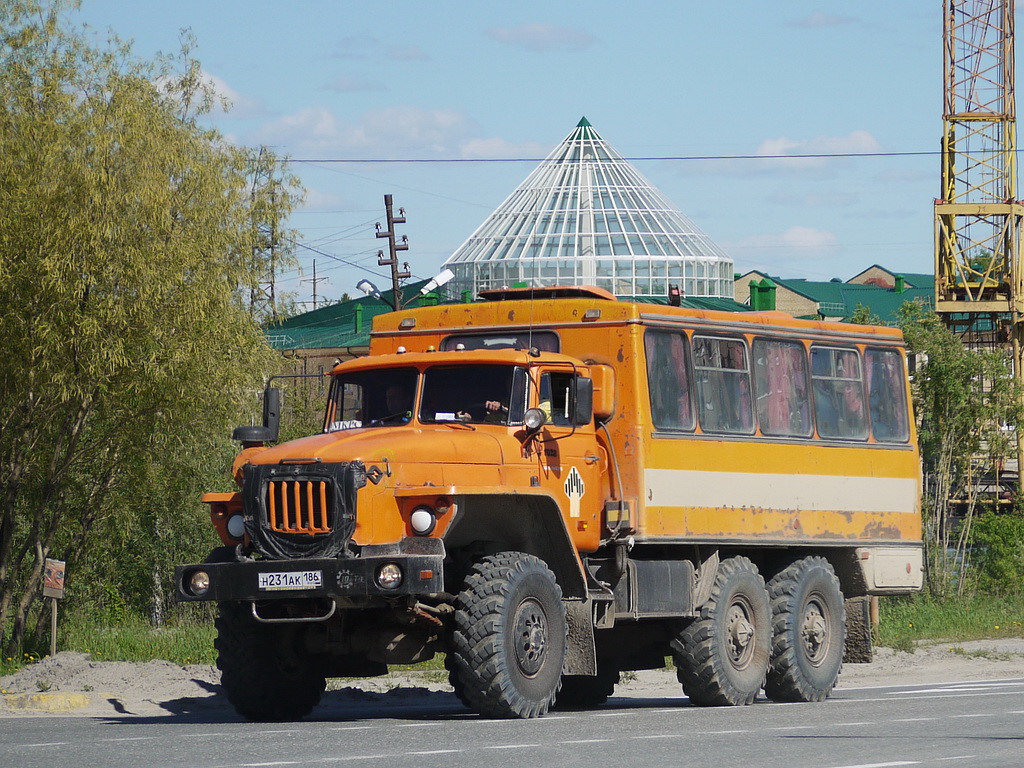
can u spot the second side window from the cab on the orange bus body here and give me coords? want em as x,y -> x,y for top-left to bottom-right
693,336 -> 754,434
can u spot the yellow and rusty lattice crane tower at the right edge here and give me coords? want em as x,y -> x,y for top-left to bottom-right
935,0 -> 1024,348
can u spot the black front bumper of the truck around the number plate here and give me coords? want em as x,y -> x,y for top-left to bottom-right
174,539 -> 444,602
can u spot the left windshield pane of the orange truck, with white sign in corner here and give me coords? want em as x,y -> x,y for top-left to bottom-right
325,368 -> 417,432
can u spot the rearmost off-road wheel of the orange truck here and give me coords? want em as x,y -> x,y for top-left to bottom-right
765,557 -> 846,701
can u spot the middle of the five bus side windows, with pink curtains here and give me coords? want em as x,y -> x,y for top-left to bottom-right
754,339 -> 811,437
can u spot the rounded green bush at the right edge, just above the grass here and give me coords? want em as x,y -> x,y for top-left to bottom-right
971,512 -> 1024,595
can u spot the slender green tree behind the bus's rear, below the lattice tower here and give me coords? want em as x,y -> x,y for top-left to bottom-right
899,302 -> 1024,596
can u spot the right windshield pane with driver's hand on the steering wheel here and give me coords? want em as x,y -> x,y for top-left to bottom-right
420,366 -> 526,425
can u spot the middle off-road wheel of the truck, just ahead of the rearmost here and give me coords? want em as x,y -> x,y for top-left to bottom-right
672,557 -> 771,707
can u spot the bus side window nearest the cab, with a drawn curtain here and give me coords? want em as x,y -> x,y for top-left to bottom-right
644,331 -> 693,429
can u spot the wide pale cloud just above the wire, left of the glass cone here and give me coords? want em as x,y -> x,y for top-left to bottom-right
254,106 -> 475,158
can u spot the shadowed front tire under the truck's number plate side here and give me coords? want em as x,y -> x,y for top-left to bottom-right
215,602 -> 327,722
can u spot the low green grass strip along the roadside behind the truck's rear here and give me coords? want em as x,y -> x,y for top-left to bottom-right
876,594 -> 1024,650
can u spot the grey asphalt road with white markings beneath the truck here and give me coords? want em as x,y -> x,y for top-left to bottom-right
0,679 -> 1024,768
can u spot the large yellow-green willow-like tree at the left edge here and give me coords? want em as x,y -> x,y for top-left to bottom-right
0,0 -> 298,655
